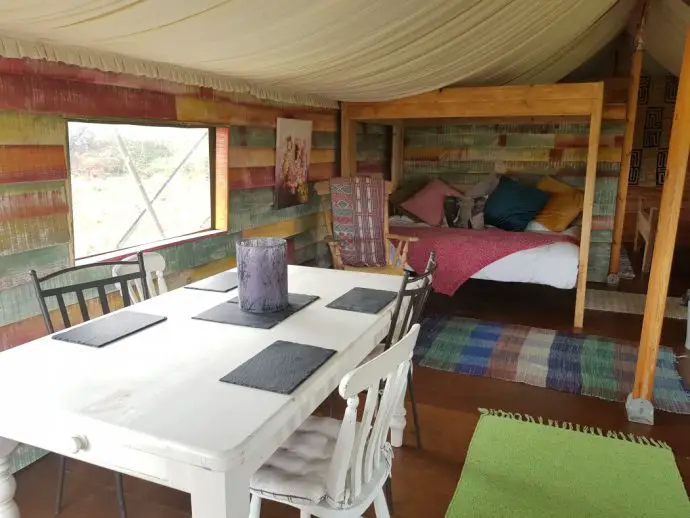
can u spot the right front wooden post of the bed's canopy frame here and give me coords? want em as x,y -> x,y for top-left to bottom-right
573,83 -> 604,329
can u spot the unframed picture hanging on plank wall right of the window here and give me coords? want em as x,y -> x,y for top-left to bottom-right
274,118 -> 312,209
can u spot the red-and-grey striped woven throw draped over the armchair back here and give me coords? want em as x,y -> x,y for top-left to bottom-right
330,176 -> 386,266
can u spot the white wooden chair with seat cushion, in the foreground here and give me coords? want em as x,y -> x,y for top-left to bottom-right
249,324 -> 419,518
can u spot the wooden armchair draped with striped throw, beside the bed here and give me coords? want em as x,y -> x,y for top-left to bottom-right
314,175 -> 418,275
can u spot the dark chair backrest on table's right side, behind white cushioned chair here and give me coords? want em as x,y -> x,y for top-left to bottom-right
384,251 -> 437,349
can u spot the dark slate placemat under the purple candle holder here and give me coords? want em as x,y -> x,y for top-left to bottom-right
192,293 -> 319,329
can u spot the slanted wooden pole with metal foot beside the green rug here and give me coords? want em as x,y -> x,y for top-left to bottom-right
628,31 -> 690,424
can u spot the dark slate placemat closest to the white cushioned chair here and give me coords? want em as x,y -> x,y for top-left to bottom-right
220,340 -> 335,394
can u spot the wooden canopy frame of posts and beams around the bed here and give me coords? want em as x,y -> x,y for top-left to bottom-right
340,82 -> 600,329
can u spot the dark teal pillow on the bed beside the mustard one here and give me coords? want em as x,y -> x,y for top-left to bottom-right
484,176 -> 549,231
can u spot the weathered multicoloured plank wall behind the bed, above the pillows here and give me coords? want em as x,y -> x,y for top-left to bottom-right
403,121 -> 624,282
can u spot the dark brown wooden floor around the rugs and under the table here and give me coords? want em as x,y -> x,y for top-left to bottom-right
10,243 -> 690,518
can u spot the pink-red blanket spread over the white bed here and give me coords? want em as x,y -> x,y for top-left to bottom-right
391,227 -> 573,295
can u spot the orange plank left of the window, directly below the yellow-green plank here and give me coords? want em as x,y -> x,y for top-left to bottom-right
0,146 -> 67,183
